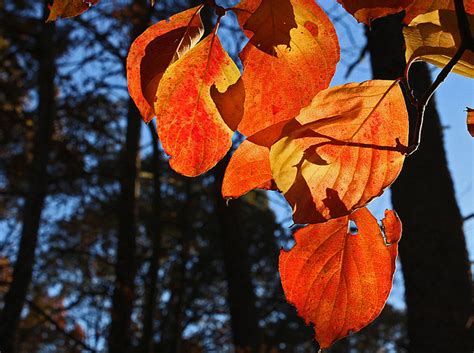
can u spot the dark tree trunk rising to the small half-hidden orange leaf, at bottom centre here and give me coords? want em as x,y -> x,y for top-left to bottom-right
214,156 -> 261,353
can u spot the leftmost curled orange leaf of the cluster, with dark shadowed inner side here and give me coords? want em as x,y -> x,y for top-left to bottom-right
127,6 -> 204,123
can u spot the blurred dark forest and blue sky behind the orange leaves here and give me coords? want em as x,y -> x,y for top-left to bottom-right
0,0 -> 474,353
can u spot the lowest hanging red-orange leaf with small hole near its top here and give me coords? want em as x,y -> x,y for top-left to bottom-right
280,208 -> 402,349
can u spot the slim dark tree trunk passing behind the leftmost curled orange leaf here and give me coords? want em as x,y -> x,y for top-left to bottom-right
108,0 -> 151,353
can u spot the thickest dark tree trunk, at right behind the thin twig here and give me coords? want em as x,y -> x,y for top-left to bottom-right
367,16 -> 474,353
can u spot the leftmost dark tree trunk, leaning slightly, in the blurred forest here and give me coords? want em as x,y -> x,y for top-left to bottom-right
0,1 -> 56,353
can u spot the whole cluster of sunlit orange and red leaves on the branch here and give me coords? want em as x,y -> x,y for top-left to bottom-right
52,0 -> 474,348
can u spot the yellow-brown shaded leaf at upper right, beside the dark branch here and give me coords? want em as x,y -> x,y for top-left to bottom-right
403,10 -> 474,77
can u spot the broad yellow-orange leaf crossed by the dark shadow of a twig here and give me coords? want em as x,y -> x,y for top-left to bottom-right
270,80 -> 408,224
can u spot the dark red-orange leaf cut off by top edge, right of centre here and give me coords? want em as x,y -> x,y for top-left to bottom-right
337,0 -> 414,25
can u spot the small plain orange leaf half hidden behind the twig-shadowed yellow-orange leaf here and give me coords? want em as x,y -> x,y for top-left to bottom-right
222,140 -> 273,198
